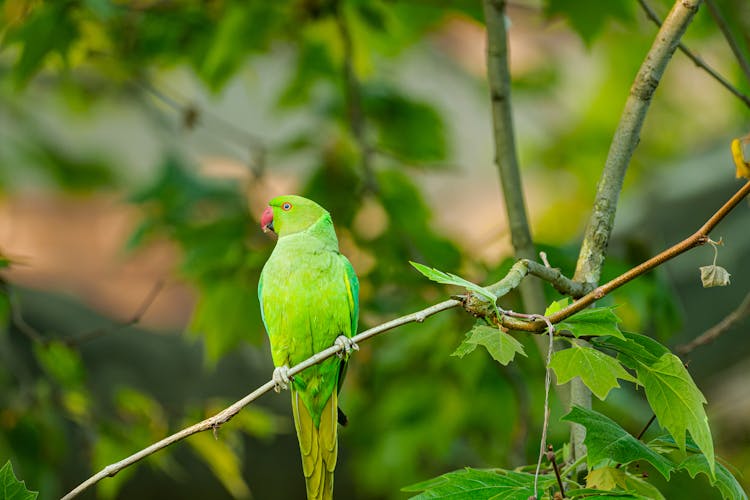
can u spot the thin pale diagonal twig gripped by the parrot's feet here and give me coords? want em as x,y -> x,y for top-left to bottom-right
62,299 -> 461,500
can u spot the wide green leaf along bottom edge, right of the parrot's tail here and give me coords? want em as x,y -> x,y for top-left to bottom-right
402,467 -> 555,500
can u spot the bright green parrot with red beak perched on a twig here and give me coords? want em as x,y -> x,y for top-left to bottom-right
258,195 -> 359,500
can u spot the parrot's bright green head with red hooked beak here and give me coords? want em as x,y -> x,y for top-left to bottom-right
260,195 -> 328,237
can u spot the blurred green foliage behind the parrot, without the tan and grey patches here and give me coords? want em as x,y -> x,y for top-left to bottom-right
0,0 -> 750,498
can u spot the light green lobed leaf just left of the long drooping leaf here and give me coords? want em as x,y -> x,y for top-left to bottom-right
549,344 -> 637,401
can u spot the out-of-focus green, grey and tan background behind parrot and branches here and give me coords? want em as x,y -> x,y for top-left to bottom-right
0,0 -> 750,499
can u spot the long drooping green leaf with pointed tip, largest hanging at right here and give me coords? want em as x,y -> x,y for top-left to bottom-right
636,353 -> 716,476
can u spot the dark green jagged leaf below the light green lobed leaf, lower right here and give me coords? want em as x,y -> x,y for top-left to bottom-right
562,406 -> 674,479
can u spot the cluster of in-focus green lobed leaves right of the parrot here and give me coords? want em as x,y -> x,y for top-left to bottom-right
405,264 -> 747,499
